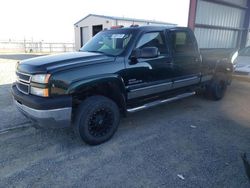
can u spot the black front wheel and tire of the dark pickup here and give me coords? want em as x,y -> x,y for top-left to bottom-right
74,96 -> 120,145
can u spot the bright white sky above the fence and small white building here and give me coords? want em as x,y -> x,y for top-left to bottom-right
0,0 -> 189,42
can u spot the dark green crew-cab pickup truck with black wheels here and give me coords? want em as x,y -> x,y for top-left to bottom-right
12,26 -> 236,145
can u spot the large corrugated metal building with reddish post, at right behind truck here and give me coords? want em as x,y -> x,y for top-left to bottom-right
188,0 -> 250,48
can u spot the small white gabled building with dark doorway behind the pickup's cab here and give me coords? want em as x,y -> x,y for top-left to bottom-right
74,14 -> 176,50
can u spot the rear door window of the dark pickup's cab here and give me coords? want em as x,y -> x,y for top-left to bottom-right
172,31 -> 196,54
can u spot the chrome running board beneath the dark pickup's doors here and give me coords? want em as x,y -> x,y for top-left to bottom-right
127,92 -> 195,113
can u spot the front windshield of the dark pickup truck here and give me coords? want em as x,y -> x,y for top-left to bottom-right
80,30 -> 133,56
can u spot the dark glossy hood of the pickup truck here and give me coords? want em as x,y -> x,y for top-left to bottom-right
17,52 -> 115,74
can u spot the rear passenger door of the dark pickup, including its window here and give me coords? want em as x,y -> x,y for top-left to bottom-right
169,29 -> 201,88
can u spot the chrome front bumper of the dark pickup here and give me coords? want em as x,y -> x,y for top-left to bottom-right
14,100 -> 72,127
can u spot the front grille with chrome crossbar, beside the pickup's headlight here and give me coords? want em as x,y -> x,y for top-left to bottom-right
16,72 -> 31,94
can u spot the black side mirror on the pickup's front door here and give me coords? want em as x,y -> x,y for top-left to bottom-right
130,47 -> 159,62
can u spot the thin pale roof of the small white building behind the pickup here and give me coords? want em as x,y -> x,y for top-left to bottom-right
74,14 -> 177,26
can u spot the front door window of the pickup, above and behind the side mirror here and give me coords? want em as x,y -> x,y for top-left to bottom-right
136,32 -> 167,54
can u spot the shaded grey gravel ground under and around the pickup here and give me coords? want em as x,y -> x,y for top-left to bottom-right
0,55 -> 250,188
